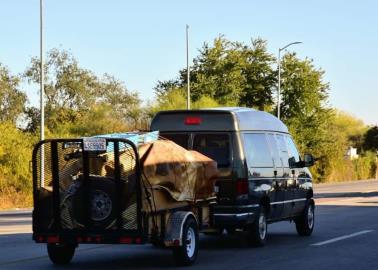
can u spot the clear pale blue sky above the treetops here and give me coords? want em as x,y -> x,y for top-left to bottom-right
0,0 -> 378,124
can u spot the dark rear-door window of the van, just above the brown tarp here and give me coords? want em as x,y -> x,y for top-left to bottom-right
193,133 -> 231,168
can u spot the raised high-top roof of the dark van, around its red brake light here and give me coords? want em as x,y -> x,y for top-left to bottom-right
151,107 -> 288,133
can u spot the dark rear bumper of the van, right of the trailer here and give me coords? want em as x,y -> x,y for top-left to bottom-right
213,204 -> 259,228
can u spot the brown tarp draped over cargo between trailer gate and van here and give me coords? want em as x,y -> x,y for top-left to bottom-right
139,140 -> 218,201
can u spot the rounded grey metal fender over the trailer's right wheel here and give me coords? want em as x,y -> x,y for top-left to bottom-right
164,211 -> 198,247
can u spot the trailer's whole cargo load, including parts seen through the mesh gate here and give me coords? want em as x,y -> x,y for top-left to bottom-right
53,133 -> 218,228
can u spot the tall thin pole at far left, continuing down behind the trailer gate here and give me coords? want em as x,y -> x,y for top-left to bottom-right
39,0 -> 45,187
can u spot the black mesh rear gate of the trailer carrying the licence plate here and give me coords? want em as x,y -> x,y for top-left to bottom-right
32,137 -> 146,244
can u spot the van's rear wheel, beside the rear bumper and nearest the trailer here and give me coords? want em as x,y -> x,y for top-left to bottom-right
247,206 -> 268,247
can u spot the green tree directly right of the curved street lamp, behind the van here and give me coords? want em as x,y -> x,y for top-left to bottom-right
281,53 -> 332,181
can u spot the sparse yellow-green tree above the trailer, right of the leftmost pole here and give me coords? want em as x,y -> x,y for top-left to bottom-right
25,49 -> 140,135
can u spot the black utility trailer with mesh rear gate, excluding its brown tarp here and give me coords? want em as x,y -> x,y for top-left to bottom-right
32,133 -> 215,265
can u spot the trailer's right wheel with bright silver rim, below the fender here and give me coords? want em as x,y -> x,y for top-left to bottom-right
173,217 -> 199,266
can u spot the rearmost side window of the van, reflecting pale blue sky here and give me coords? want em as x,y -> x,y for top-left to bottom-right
244,133 -> 273,168
